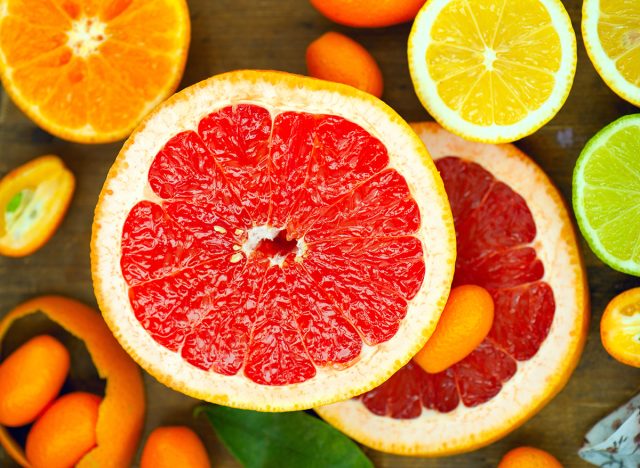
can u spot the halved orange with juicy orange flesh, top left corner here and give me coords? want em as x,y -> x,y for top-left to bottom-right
0,0 -> 190,143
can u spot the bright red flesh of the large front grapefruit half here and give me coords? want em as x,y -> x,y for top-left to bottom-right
121,104 -> 425,385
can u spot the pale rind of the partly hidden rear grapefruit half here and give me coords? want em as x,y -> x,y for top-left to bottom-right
316,123 -> 589,457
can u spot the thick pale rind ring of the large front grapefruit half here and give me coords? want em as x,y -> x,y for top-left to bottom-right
91,70 -> 455,411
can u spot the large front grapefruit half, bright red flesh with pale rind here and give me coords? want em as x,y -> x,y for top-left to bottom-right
91,71 -> 455,411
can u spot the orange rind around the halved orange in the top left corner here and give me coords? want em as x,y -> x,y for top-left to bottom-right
0,0 -> 191,144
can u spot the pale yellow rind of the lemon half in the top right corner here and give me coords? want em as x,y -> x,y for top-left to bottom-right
582,0 -> 640,106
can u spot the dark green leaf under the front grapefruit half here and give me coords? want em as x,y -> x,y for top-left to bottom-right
195,405 -> 373,468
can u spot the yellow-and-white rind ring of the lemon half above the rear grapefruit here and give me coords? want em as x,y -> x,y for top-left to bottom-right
408,0 -> 577,143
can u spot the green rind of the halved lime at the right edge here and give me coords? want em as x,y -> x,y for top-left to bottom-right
573,114 -> 640,276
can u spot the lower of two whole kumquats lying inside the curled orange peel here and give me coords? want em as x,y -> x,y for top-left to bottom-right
26,392 -> 102,468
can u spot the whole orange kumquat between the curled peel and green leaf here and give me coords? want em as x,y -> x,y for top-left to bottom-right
140,426 -> 211,468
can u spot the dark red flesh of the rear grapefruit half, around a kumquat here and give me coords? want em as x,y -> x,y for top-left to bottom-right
362,157 -> 555,418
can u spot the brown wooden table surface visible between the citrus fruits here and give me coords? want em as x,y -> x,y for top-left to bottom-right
0,0 -> 640,467
